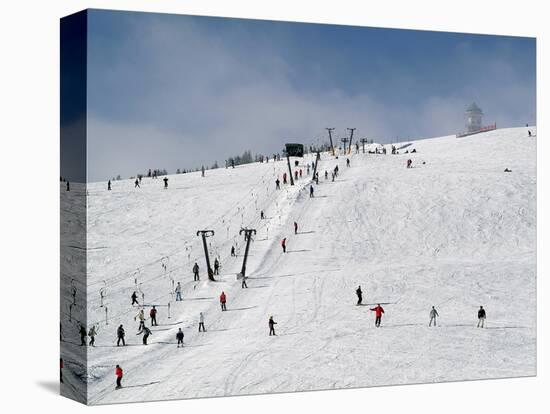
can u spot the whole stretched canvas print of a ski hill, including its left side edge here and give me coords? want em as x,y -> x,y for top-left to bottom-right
60,10 -> 537,404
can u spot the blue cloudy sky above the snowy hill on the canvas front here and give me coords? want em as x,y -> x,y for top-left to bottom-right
88,10 -> 536,181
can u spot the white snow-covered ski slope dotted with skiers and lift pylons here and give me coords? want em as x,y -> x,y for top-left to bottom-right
62,128 -> 536,404
